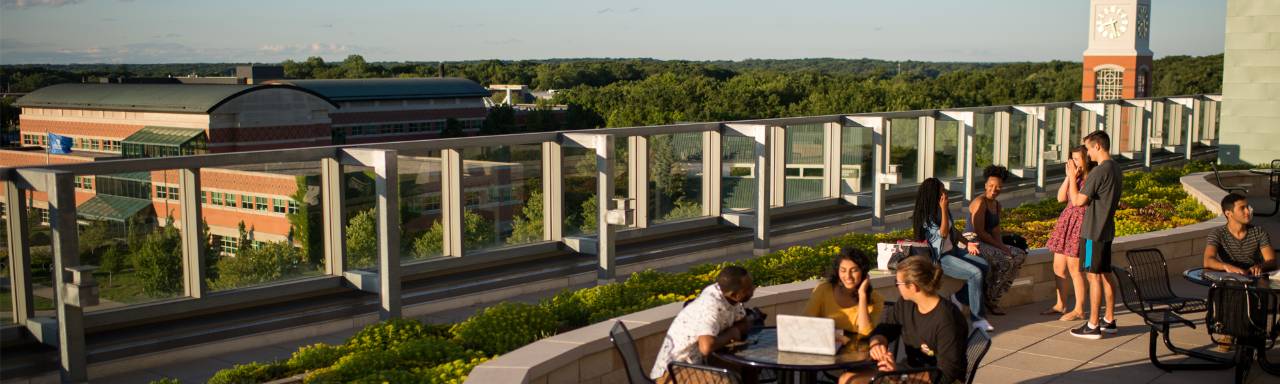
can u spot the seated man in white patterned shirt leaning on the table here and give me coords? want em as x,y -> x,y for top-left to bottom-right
649,266 -> 755,383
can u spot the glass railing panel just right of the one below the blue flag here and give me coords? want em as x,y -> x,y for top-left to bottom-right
199,161 -> 322,291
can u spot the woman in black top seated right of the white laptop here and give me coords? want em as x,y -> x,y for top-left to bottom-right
870,256 -> 968,383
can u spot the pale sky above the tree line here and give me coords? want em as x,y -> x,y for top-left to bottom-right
0,0 -> 1226,64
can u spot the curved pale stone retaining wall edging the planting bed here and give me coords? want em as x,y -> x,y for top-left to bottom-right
467,172 -> 1228,384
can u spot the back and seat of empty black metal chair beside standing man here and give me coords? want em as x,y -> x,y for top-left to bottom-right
1124,248 -> 1206,315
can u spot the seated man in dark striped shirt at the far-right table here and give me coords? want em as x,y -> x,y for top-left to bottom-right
1204,193 -> 1276,275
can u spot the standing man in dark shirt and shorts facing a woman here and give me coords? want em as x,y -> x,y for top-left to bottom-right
1066,131 -> 1124,339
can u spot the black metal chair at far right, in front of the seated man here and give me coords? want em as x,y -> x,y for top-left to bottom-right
1204,283 -> 1280,383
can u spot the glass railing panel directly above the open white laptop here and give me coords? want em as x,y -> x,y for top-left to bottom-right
783,124 -> 826,204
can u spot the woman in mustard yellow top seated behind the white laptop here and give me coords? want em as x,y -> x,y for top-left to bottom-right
804,248 -> 884,384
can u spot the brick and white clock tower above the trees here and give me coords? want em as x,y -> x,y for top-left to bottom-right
1080,0 -> 1152,100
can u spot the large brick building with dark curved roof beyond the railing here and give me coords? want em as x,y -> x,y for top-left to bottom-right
0,78 -> 509,252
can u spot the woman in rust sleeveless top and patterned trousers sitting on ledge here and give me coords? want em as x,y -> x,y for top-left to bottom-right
968,165 -> 1027,315
